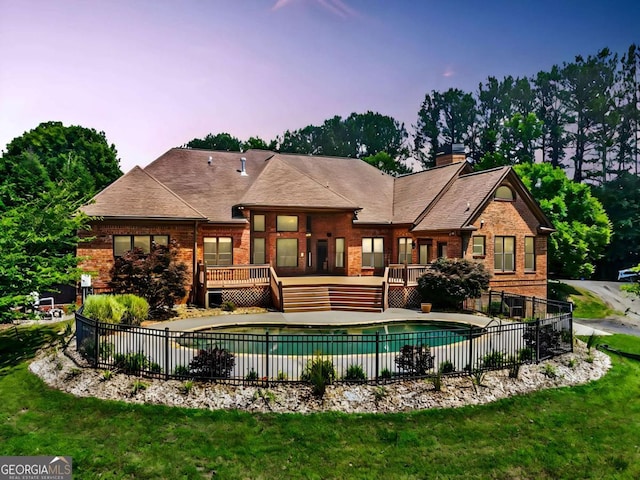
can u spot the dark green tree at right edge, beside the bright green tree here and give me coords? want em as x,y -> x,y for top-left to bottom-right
594,172 -> 640,279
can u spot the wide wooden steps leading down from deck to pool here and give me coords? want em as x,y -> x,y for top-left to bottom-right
282,284 -> 383,312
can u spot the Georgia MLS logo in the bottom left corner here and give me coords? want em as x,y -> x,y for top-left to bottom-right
0,457 -> 73,480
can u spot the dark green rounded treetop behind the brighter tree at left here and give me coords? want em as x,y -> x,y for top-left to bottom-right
0,122 -> 122,199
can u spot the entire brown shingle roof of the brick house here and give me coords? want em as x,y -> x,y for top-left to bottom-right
83,148 -> 548,230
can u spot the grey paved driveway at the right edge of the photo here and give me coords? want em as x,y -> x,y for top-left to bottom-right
561,280 -> 640,336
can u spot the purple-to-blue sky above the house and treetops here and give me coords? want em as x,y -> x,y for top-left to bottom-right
0,0 -> 640,172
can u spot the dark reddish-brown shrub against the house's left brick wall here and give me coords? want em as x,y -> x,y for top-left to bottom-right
109,240 -> 187,314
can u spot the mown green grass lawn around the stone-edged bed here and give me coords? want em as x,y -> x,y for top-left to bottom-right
0,320 -> 640,479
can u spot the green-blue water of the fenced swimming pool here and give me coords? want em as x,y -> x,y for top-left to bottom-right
179,322 -> 477,355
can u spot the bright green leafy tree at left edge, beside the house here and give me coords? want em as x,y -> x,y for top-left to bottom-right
0,188 -> 88,322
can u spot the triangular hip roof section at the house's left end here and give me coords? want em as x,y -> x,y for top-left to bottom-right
81,166 -> 205,220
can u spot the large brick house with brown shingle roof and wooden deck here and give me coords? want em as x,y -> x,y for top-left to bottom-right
77,148 -> 553,308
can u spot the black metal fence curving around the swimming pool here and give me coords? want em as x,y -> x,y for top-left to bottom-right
76,296 -> 573,384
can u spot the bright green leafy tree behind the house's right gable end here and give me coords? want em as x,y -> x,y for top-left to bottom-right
514,163 -> 611,278
